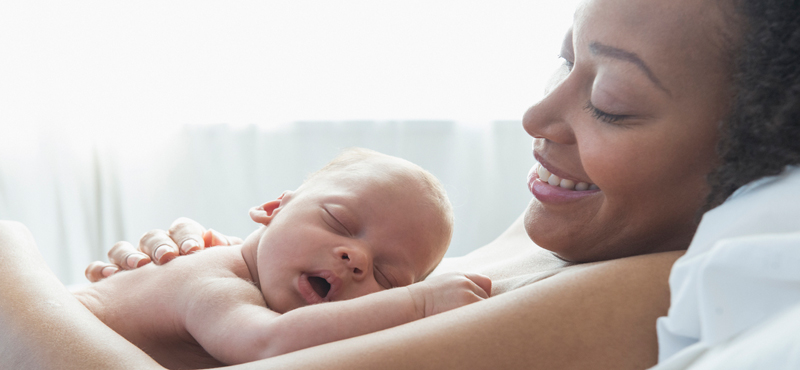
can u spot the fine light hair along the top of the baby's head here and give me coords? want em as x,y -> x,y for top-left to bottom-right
305,148 -> 454,241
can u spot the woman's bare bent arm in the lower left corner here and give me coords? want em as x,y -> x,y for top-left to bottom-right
0,221 -> 161,369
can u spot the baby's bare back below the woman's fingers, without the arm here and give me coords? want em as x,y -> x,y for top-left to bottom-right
75,246 -> 261,368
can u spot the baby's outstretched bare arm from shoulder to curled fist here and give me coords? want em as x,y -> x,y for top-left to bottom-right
186,273 -> 491,364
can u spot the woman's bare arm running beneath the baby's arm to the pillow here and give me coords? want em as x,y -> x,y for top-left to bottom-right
225,252 -> 682,370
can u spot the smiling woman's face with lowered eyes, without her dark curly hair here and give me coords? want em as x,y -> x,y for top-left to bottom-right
523,0 -> 730,262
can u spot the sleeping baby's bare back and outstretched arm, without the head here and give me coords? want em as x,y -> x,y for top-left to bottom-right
75,246 -> 491,368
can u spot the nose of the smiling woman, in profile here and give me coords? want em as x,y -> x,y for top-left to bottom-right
522,68 -> 580,145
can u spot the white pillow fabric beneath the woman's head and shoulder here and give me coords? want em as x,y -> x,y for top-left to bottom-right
656,166 -> 800,369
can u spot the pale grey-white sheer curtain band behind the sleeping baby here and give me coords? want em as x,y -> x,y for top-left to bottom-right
0,121 -> 534,284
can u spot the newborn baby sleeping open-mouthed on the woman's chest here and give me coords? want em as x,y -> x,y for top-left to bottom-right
75,149 -> 491,367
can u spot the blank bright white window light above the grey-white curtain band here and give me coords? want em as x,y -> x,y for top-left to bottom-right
0,0 -> 575,133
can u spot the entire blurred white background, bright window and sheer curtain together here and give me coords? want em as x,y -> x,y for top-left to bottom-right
0,0 -> 577,284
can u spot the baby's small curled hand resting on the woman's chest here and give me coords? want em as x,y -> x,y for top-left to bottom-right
407,272 -> 492,317
